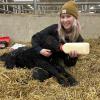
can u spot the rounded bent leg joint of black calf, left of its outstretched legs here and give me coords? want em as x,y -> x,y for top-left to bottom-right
32,67 -> 50,82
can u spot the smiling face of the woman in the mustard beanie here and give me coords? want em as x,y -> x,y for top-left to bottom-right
60,14 -> 74,30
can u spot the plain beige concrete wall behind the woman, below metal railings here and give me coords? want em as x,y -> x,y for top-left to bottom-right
0,14 -> 100,42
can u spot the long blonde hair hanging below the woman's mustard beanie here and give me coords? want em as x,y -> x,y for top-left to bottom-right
58,18 -> 81,42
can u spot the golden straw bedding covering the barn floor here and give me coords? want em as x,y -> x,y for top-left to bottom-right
0,38 -> 100,100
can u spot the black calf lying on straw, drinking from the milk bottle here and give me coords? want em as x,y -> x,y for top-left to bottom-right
0,36 -> 76,86
